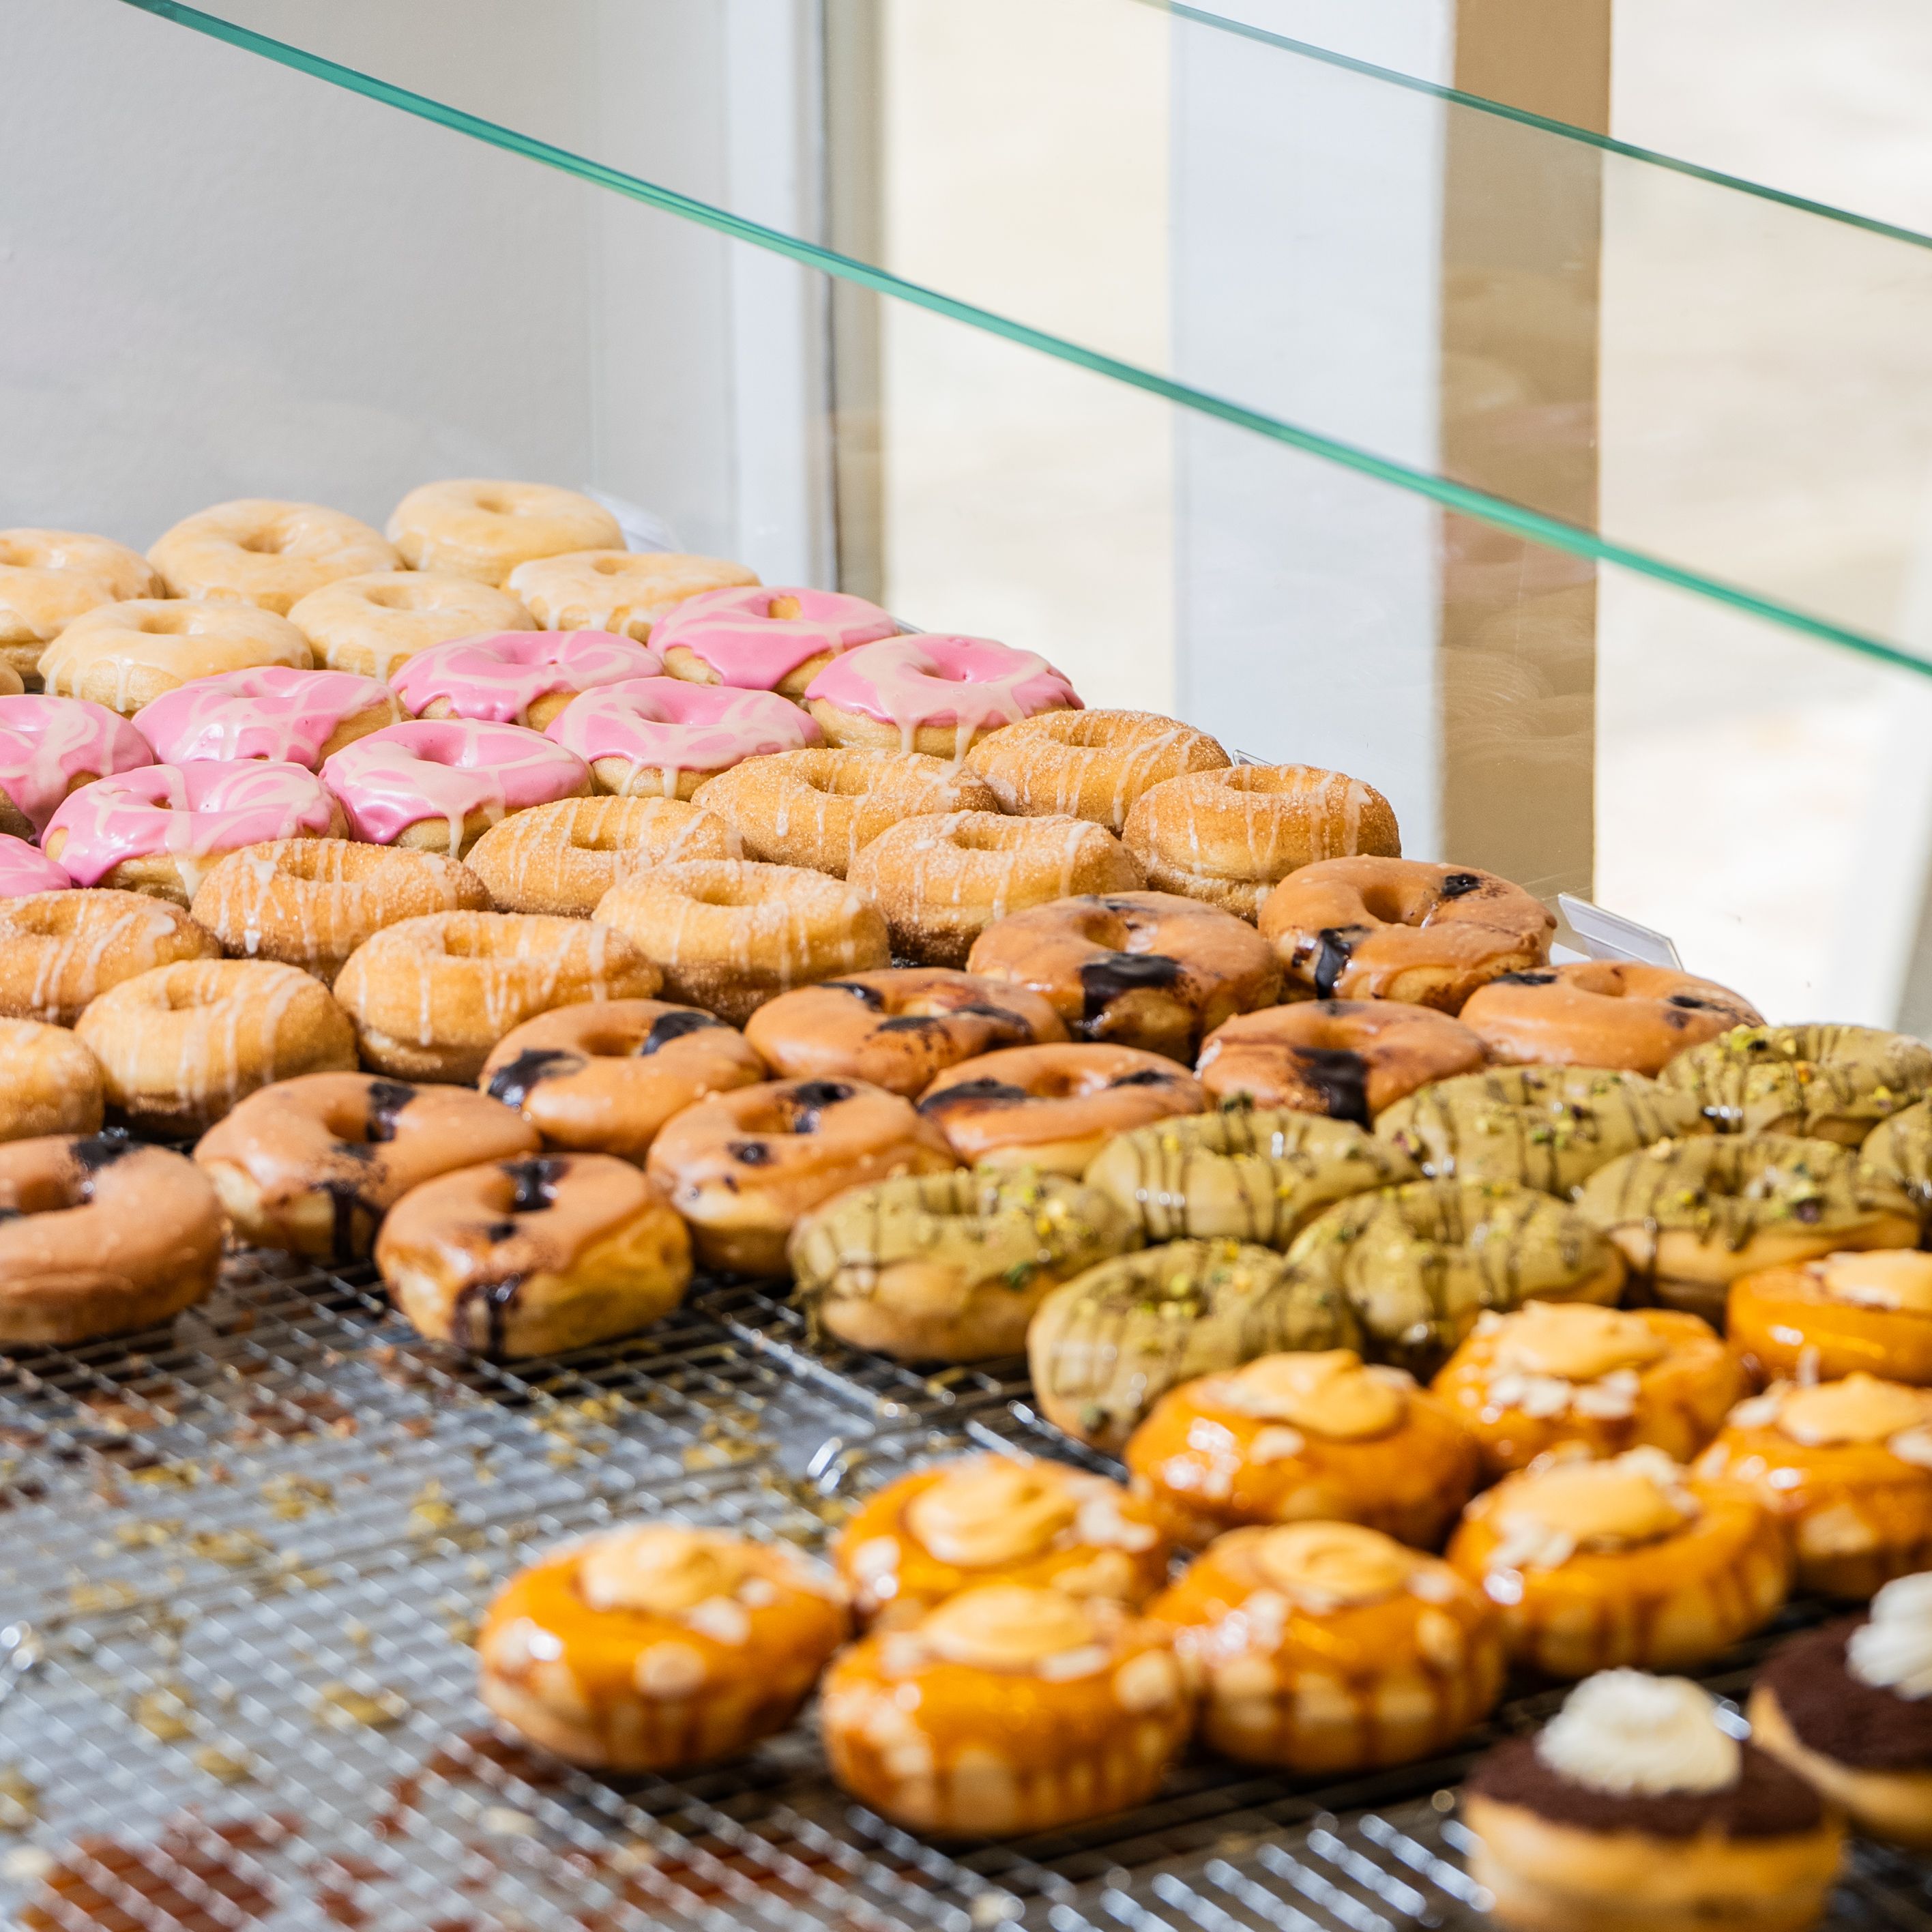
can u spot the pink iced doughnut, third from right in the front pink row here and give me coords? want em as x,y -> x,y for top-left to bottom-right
323,719 -> 591,858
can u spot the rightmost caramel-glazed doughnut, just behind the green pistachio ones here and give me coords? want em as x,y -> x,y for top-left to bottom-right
1463,961 -> 1764,1074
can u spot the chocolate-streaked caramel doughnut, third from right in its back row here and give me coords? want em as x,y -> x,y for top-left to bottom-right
746,966 -> 1066,1099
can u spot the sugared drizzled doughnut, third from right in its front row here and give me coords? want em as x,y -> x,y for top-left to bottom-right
593,858 -> 891,1026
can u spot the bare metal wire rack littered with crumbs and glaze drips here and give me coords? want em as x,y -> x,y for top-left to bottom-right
0,1250 -> 1932,1932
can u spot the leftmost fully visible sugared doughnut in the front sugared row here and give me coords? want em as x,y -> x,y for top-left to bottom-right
74,961 -> 355,1138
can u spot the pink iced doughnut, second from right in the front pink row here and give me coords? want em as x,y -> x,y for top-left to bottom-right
548,678 -> 819,798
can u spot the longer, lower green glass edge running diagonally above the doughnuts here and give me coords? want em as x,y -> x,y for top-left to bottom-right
121,0 -> 1932,676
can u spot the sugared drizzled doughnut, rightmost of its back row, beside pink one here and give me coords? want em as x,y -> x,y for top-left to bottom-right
966,711 -> 1229,830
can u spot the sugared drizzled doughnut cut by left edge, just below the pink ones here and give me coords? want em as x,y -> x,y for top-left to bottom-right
0,889 -> 222,1026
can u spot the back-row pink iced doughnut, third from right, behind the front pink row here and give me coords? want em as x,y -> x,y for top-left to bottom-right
133,664 -> 402,771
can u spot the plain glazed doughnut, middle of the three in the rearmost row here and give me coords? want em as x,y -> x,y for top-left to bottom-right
147,497 -> 396,616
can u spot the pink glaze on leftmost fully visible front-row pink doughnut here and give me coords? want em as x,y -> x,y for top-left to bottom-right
40,757 -> 334,885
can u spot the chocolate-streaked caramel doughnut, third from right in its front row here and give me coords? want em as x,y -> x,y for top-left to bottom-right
920,1043 -> 1208,1180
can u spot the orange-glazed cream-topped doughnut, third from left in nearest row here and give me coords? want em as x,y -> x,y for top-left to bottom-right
1147,1523 -> 1505,1777
